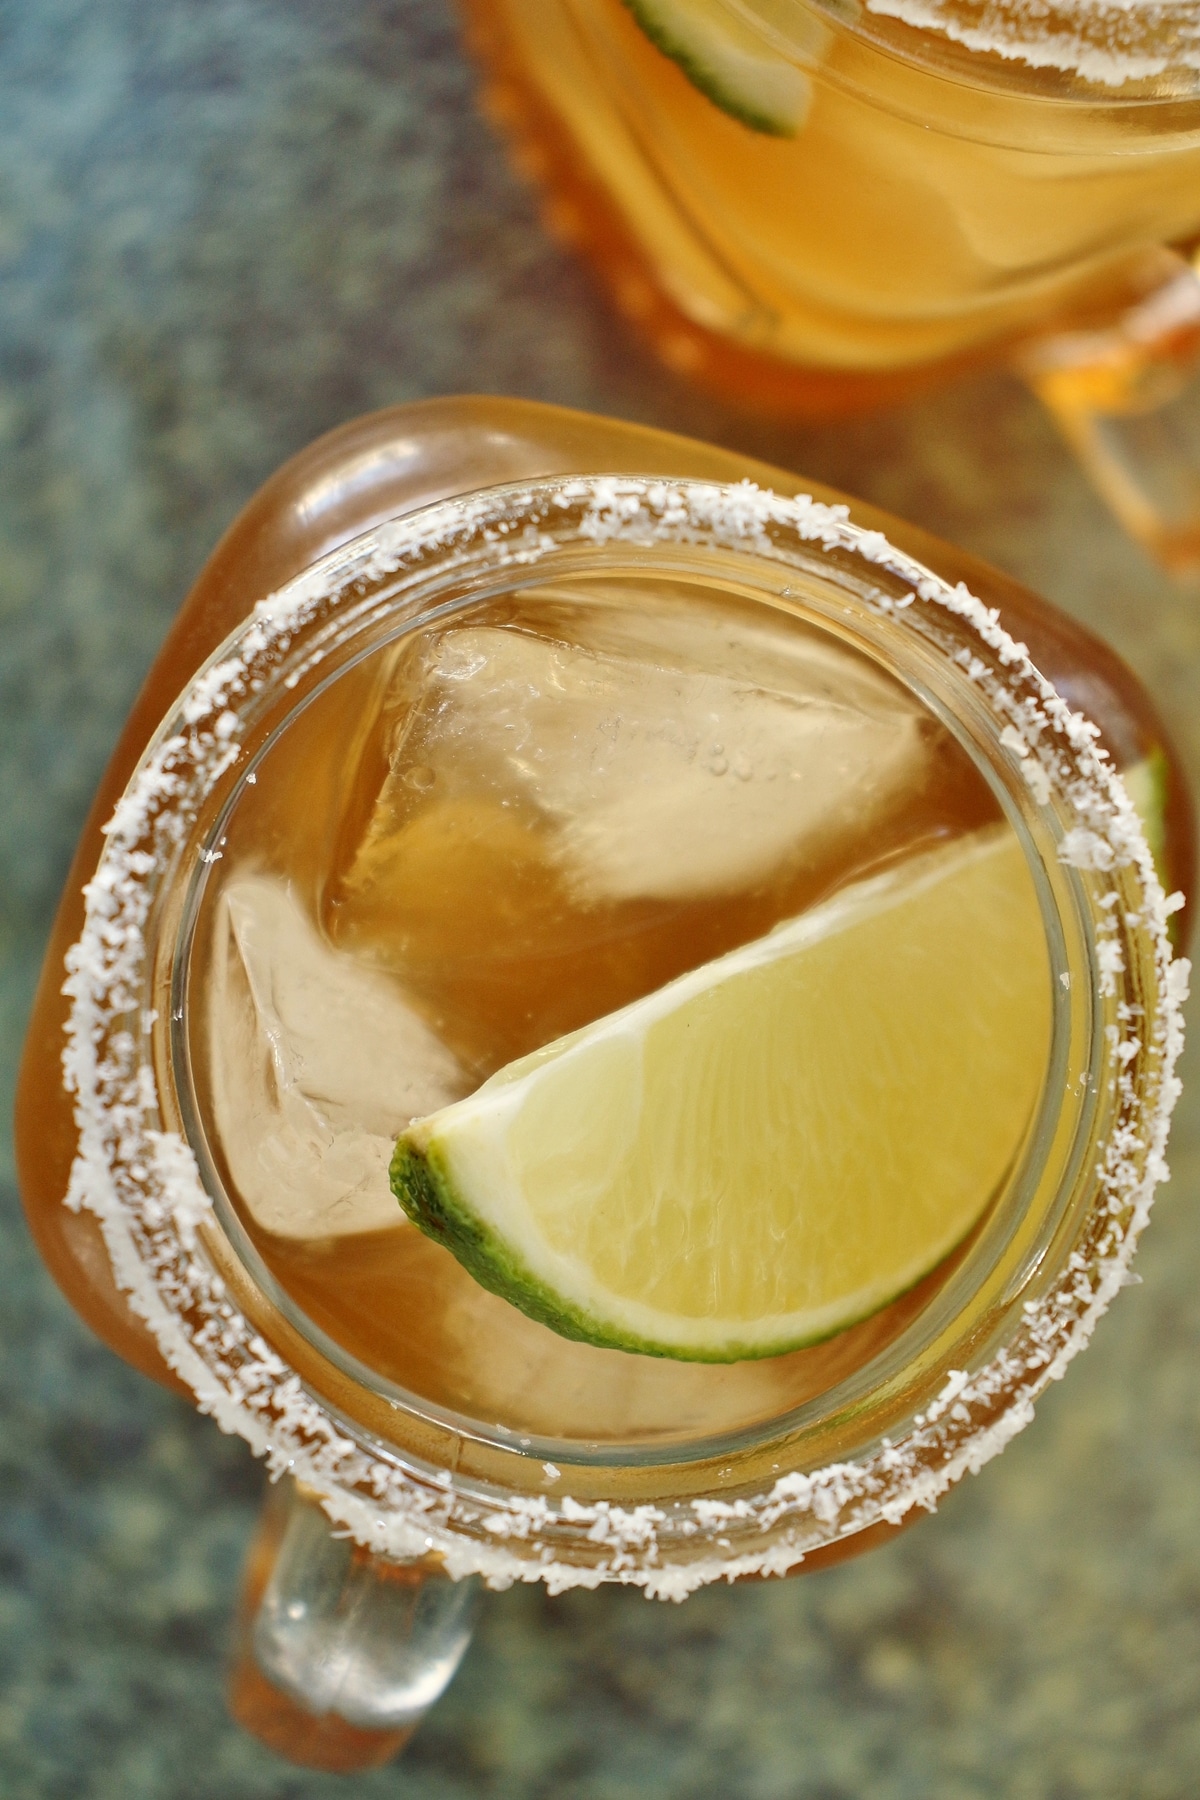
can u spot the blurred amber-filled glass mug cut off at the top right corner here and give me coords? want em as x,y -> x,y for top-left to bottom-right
464,0 -> 1200,569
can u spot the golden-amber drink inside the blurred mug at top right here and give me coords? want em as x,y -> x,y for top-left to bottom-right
466,0 -> 1200,385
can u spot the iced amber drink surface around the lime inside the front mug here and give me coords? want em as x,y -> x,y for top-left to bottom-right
189,581 -> 1049,1442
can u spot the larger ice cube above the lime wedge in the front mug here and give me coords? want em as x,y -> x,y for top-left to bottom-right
338,607 -> 936,914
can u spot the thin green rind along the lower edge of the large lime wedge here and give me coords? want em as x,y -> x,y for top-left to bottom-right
389,1138 -> 942,1363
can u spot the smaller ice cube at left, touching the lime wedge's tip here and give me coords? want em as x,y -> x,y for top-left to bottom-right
205,873 -> 473,1238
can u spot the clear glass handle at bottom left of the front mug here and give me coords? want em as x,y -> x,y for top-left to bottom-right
228,1478 -> 480,1773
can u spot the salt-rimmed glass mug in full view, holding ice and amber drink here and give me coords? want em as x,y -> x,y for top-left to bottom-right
18,400 -> 1193,1769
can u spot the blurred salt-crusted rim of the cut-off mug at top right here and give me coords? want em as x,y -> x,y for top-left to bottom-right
865,0 -> 1200,88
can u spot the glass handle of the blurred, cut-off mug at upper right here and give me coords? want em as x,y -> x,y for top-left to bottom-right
1015,248 -> 1200,580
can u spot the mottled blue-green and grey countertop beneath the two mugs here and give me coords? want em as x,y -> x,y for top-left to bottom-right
0,0 -> 1200,1800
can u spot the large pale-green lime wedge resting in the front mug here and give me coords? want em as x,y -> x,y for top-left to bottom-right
392,828 -> 1051,1363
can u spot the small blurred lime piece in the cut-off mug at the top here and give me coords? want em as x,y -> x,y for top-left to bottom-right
624,0 -> 811,137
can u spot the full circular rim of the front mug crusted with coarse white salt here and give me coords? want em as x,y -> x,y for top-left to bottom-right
63,475 -> 1189,1600
